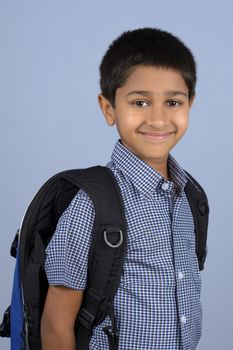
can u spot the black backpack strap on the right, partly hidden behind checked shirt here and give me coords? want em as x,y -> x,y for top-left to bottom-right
185,171 -> 209,271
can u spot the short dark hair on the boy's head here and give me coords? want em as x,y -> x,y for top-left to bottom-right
99,28 -> 196,108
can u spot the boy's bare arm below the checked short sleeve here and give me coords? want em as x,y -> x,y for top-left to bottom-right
41,286 -> 84,350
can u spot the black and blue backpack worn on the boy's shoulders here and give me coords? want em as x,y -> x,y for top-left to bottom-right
0,166 -> 209,350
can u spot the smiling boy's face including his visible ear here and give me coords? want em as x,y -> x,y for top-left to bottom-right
98,66 -> 193,168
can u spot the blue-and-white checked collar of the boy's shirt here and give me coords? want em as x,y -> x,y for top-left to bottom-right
112,140 -> 187,195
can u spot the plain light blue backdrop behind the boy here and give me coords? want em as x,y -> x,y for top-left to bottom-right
0,0 -> 233,350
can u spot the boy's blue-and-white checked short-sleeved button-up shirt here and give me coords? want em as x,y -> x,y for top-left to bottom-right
45,141 -> 202,350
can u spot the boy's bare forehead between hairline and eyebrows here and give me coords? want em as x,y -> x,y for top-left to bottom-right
116,66 -> 188,94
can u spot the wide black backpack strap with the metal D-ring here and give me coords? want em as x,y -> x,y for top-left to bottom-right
62,166 -> 126,350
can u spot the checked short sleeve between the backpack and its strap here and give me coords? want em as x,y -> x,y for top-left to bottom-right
45,190 -> 95,290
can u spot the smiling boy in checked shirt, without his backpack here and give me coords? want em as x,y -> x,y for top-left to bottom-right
41,28 -> 206,350
